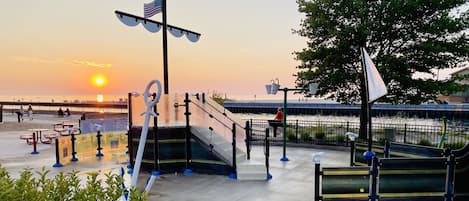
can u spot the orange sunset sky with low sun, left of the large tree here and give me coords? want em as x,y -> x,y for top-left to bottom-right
0,0 -> 306,98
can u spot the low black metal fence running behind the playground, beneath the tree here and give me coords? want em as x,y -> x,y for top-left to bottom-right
245,119 -> 469,148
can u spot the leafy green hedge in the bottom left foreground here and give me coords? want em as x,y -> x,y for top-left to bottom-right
0,166 -> 147,201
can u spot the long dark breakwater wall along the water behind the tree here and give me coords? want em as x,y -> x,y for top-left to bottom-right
223,101 -> 469,119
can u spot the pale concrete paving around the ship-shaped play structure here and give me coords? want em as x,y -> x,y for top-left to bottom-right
0,112 -> 349,201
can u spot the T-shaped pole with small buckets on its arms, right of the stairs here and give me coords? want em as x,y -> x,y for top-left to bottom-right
266,79 -> 318,162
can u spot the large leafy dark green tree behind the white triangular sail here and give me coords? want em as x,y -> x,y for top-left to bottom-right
294,0 -> 469,137
